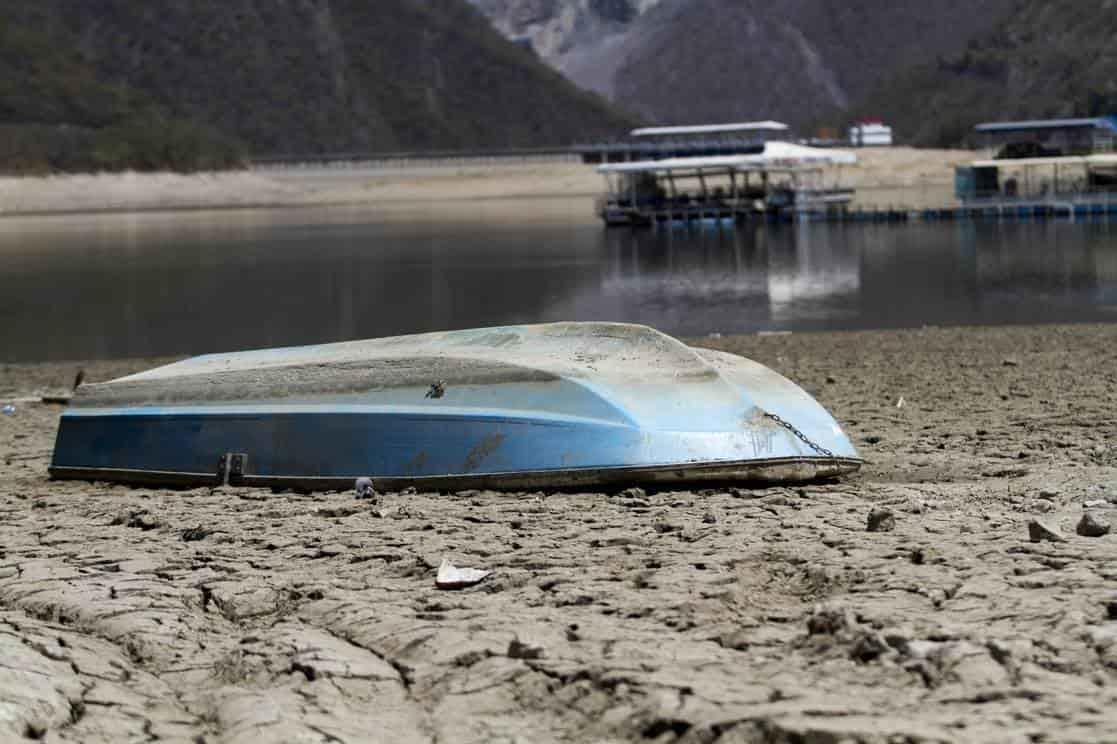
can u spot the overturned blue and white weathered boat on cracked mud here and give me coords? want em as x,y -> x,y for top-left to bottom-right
50,323 -> 860,490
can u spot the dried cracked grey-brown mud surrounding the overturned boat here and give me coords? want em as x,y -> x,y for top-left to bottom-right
0,326 -> 1117,744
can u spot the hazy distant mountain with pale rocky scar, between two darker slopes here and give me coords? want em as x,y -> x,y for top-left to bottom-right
475,0 -> 1014,126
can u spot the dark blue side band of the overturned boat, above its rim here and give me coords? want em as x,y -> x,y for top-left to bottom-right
52,409 -> 818,477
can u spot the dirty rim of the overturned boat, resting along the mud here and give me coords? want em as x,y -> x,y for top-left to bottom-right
50,457 -> 862,492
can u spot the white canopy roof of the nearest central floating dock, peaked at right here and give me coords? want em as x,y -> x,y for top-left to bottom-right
598,142 -> 857,173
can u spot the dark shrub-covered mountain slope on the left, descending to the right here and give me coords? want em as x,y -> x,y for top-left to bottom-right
0,0 -> 630,169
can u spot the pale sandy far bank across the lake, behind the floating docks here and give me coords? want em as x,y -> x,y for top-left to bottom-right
0,147 -> 973,216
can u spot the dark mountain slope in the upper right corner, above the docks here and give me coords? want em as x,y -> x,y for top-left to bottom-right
857,0 -> 1117,145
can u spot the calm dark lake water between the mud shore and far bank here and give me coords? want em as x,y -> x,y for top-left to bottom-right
0,199 -> 1117,362
